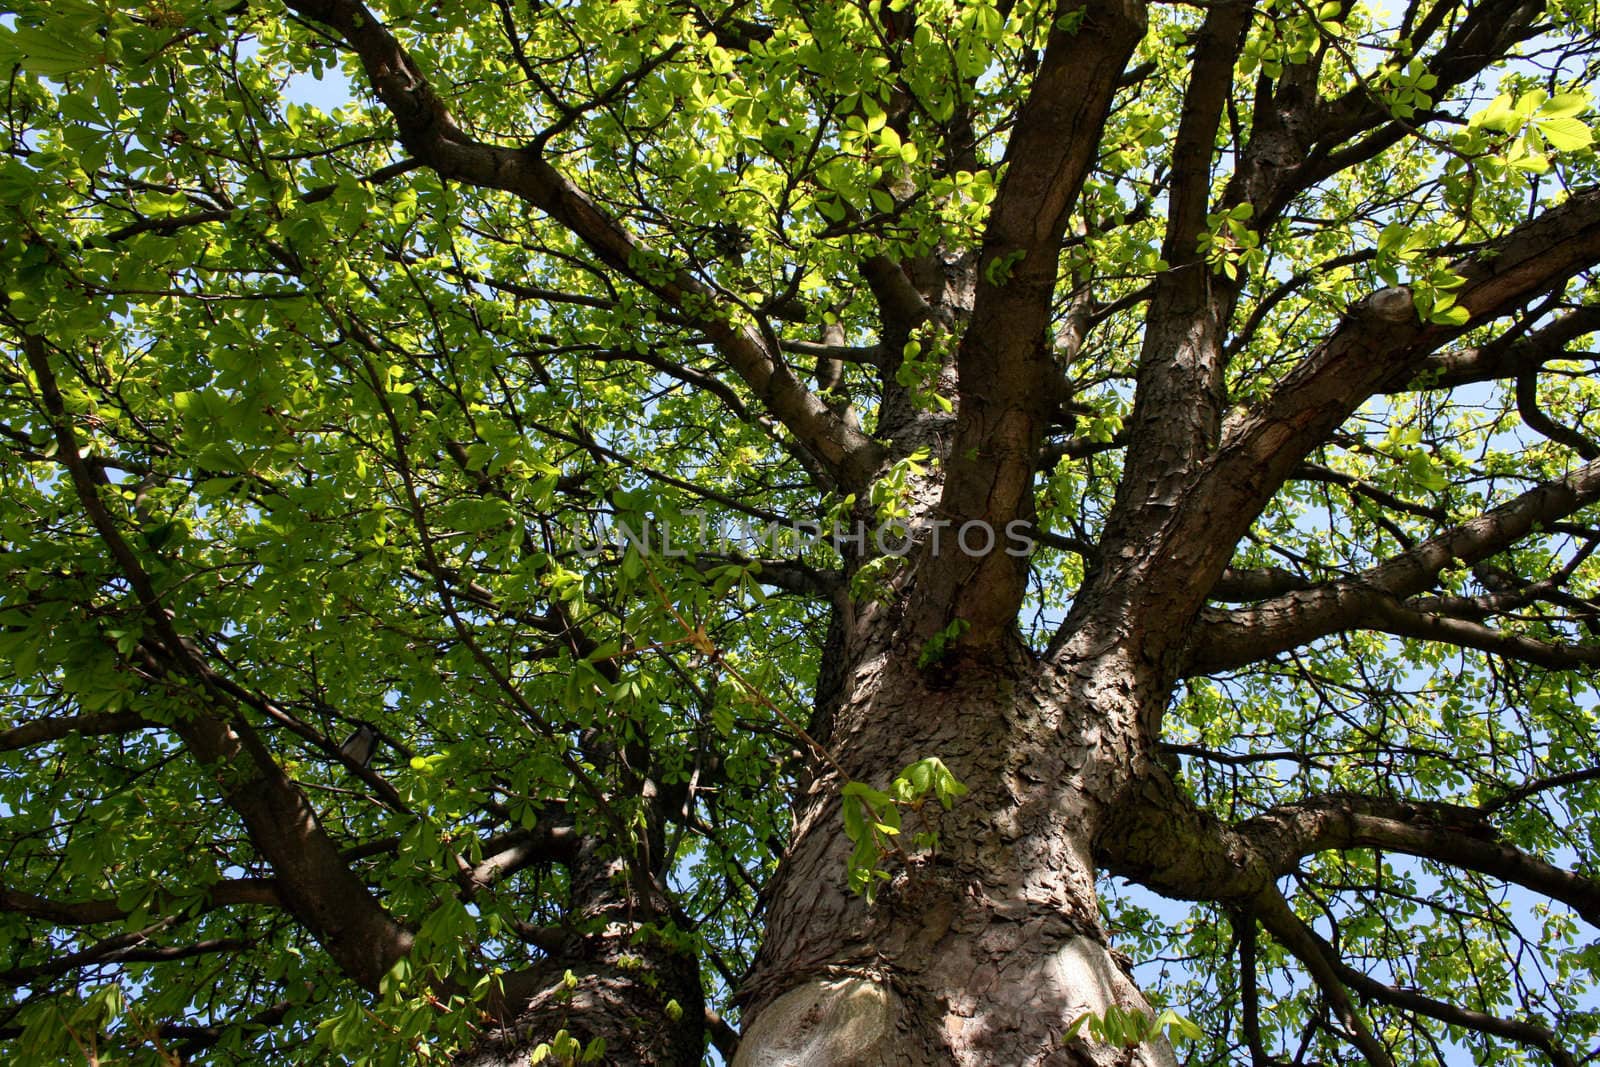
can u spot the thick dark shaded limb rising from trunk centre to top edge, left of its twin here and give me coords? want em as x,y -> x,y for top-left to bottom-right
912,0 -> 1146,649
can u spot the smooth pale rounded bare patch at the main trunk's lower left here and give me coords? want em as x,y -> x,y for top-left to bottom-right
733,977 -> 901,1067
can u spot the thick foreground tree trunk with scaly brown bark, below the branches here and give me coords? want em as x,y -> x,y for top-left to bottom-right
734,627 -> 1174,1067
